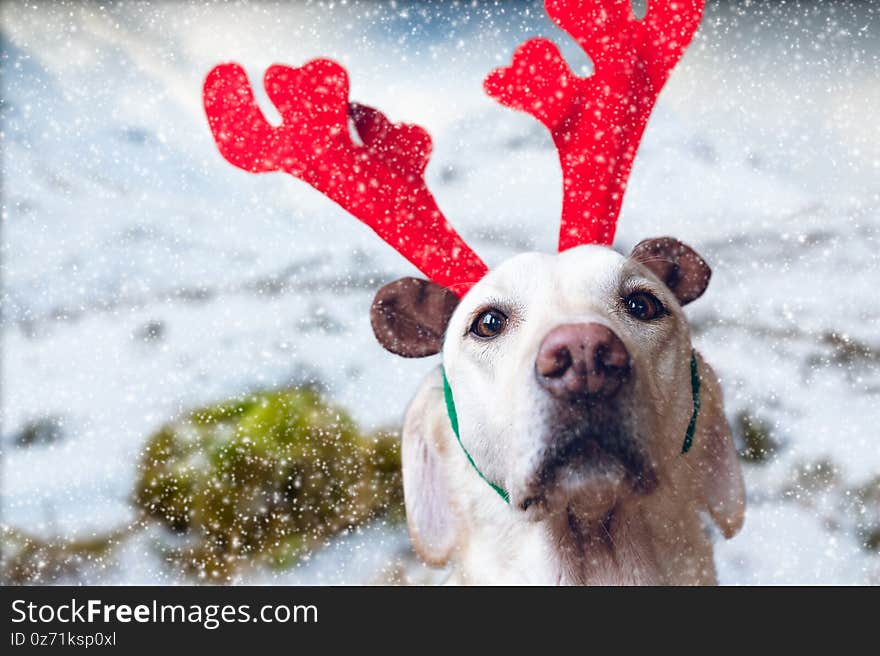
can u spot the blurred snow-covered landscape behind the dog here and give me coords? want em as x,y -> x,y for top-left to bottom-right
0,2 -> 880,584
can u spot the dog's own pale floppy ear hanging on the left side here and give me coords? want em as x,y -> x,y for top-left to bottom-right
401,369 -> 457,565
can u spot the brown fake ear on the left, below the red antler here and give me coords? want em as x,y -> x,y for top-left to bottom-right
370,278 -> 458,358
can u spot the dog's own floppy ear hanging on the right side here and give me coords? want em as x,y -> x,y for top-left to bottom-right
696,356 -> 746,538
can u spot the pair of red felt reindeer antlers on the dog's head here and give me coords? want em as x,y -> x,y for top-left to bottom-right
204,0 -> 704,296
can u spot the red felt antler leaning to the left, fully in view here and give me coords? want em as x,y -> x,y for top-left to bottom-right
204,59 -> 486,296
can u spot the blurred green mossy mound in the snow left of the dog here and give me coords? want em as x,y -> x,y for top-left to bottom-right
135,388 -> 403,580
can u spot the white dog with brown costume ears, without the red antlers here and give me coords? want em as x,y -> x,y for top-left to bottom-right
371,237 -> 745,585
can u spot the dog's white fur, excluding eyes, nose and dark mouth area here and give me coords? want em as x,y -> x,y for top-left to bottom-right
403,246 -> 745,584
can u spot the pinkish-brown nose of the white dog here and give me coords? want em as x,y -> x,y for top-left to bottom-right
535,323 -> 630,400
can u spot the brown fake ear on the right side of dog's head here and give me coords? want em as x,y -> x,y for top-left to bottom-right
630,237 -> 712,305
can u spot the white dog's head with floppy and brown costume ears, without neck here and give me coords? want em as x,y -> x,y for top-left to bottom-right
372,238 -> 743,561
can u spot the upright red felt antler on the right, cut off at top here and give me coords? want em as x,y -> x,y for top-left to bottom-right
484,0 -> 704,251
